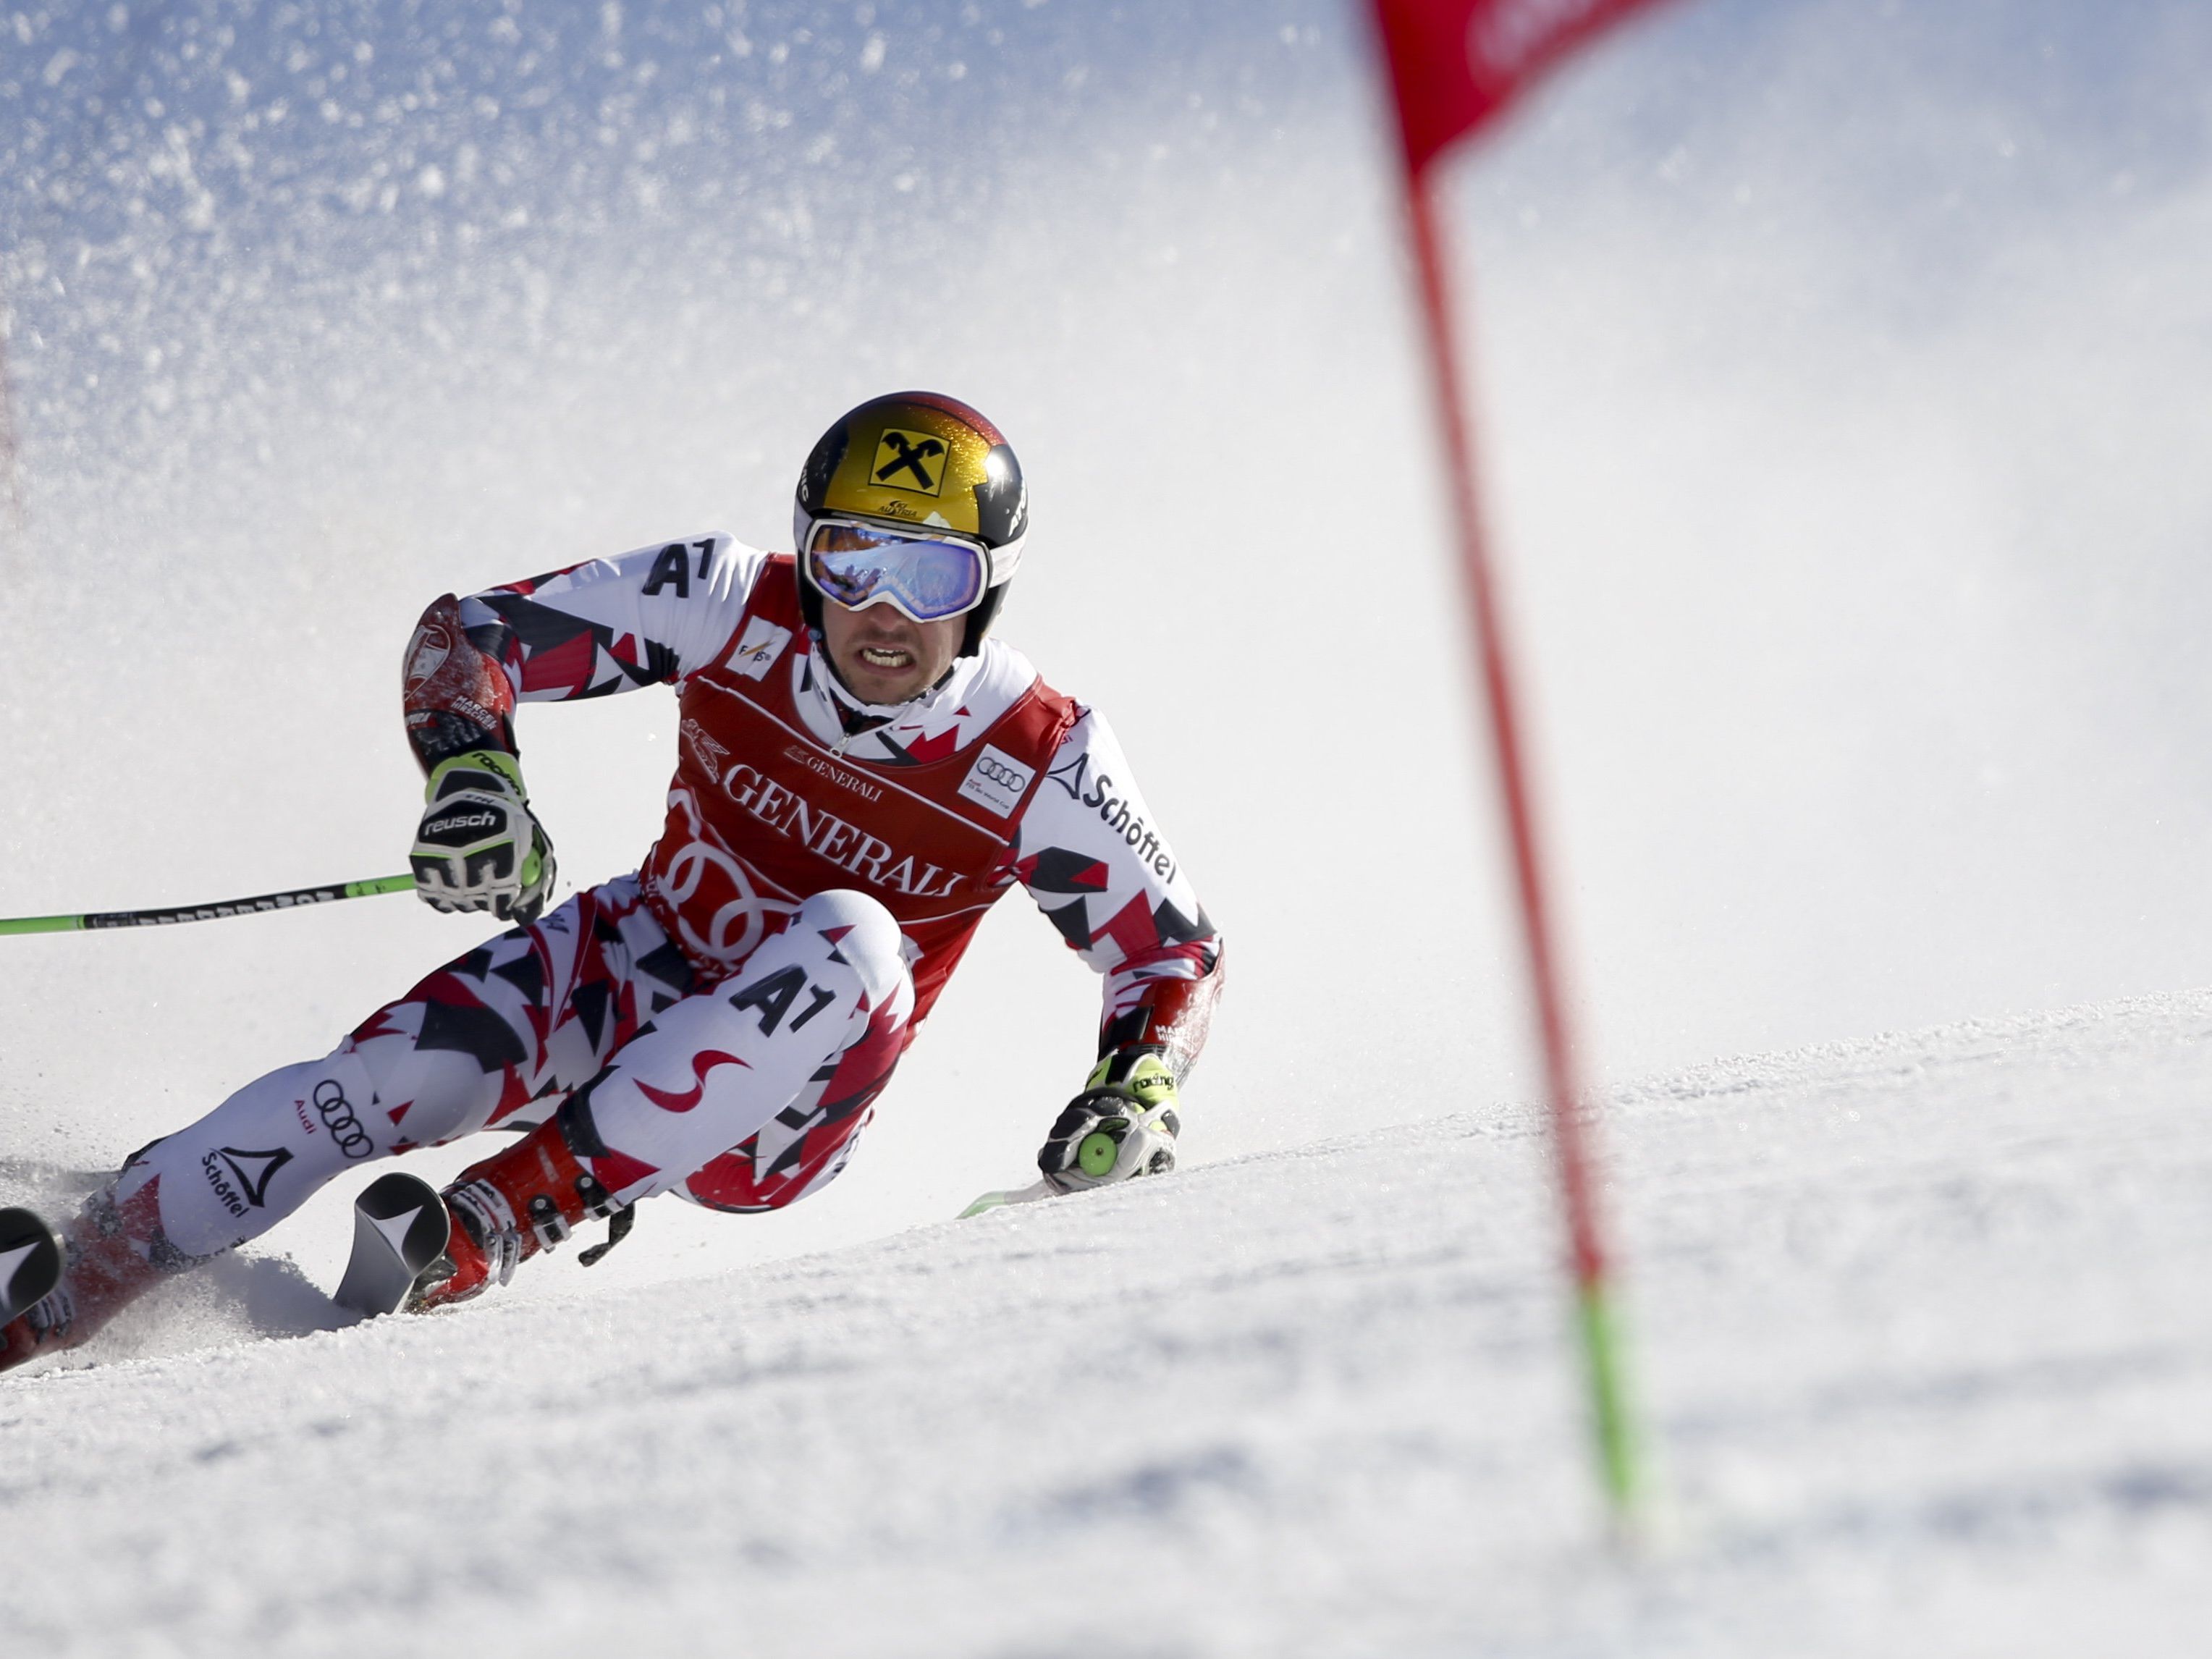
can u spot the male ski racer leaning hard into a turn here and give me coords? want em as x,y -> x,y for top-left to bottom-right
0,392 -> 1221,1369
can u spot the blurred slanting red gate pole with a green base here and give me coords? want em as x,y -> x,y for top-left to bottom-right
1405,170 -> 1642,1522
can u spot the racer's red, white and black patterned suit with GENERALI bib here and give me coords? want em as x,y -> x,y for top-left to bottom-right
106,536 -> 1221,1265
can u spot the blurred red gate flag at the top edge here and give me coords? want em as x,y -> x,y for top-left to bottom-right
1374,0 -> 1652,174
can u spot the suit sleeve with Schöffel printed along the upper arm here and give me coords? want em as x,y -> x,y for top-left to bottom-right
1016,710 -> 1221,1077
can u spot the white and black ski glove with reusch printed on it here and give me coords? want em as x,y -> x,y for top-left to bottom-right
407,750 -> 553,922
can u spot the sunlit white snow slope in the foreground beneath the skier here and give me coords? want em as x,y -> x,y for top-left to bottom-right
0,993 -> 2212,1659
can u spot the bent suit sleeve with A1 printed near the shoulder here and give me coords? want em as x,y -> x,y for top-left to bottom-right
402,536 -> 767,769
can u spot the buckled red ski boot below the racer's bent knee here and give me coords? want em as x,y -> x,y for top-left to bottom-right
407,1119 -> 630,1314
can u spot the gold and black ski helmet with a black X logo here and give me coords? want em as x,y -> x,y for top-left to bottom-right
792,392 -> 1029,657
